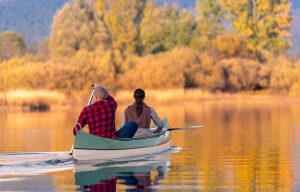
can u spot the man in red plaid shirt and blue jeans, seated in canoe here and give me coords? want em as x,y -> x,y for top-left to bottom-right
73,85 -> 138,138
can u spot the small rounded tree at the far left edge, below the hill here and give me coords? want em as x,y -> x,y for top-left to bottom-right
0,31 -> 27,60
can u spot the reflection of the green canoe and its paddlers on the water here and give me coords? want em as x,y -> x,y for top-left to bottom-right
74,151 -> 171,191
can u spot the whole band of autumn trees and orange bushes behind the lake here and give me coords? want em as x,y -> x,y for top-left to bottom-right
0,0 -> 300,95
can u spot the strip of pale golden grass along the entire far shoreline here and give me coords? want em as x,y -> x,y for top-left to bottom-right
0,89 -> 300,110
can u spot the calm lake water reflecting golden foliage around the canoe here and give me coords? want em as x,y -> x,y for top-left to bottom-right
0,101 -> 300,192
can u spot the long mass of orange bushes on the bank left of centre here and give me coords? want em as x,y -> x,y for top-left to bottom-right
0,51 -> 116,92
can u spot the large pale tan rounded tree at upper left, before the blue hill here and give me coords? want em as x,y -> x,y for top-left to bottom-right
49,0 -> 110,56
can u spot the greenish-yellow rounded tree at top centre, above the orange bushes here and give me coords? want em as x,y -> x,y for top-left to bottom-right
141,2 -> 194,54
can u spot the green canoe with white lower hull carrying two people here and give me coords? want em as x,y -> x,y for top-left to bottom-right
73,120 -> 171,160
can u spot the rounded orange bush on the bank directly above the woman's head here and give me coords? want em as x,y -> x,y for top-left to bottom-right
119,49 -> 184,89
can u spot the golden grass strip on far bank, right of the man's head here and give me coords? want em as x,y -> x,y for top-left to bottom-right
115,89 -> 300,104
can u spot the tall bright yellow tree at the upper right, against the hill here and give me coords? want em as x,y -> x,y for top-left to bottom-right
220,0 -> 291,62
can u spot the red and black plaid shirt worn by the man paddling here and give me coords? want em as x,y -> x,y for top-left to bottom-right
73,95 -> 118,138
